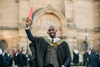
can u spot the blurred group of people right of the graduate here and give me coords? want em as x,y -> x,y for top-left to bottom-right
73,48 -> 100,67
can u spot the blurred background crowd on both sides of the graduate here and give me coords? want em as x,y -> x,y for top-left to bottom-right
0,48 -> 100,67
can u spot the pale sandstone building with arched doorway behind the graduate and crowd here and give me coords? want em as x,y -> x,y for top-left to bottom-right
0,0 -> 100,56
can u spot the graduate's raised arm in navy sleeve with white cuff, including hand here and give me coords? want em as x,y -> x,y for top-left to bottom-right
25,18 -> 34,41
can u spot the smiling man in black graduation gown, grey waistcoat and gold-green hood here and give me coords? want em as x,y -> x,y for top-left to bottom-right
26,19 -> 71,67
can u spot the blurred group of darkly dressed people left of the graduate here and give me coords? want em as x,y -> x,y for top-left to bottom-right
0,48 -> 33,67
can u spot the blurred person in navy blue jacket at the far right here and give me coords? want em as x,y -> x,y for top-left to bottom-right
89,50 -> 98,67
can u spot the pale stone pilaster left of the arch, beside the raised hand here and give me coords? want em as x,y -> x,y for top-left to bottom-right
19,0 -> 30,49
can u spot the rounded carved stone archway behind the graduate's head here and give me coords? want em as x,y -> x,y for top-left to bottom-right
31,5 -> 67,37
